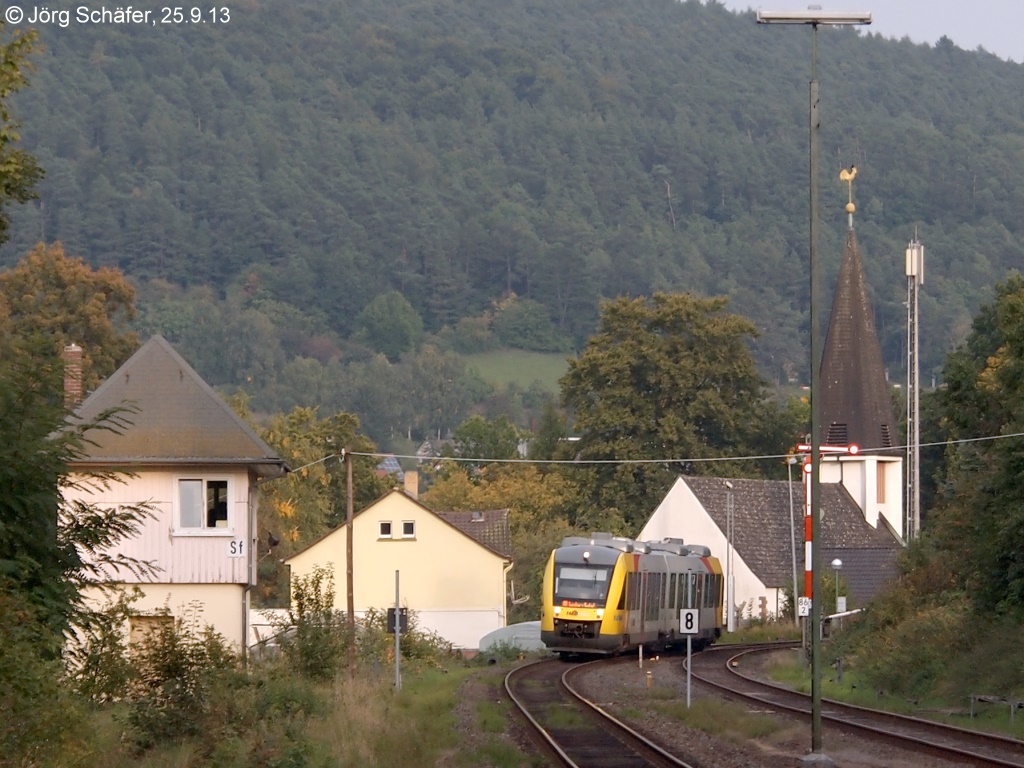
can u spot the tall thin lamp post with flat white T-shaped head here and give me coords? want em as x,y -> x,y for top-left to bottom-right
758,8 -> 871,765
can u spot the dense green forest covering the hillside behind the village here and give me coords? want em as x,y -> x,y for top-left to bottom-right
0,0 -> 1024,442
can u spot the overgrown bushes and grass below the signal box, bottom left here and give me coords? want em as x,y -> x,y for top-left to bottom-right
0,561 -> 495,768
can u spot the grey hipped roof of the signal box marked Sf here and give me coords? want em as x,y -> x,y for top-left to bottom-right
68,336 -> 287,475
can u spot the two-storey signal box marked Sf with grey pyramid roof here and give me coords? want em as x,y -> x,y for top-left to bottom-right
64,336 -> 288,648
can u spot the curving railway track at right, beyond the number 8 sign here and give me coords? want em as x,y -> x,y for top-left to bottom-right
690,644 -> 1024,768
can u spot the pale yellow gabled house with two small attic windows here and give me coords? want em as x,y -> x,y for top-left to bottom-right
285,489 -> 512,649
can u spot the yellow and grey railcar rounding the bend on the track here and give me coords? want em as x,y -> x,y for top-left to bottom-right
541,534 -> 723,657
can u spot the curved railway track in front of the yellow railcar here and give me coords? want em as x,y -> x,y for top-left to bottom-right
505,660 -> 696,768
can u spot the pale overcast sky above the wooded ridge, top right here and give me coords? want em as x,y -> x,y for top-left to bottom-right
721,0 -> 1024,62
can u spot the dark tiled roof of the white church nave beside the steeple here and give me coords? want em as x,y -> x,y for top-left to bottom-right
683,477 -> 903,604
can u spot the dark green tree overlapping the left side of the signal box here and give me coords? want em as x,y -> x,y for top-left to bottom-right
0,340 -> 150,652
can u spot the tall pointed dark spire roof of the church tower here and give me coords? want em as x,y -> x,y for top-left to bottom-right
820,228 -> 897,453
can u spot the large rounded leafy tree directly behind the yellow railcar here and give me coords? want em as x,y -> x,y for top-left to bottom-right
561,294 -> 765,532
